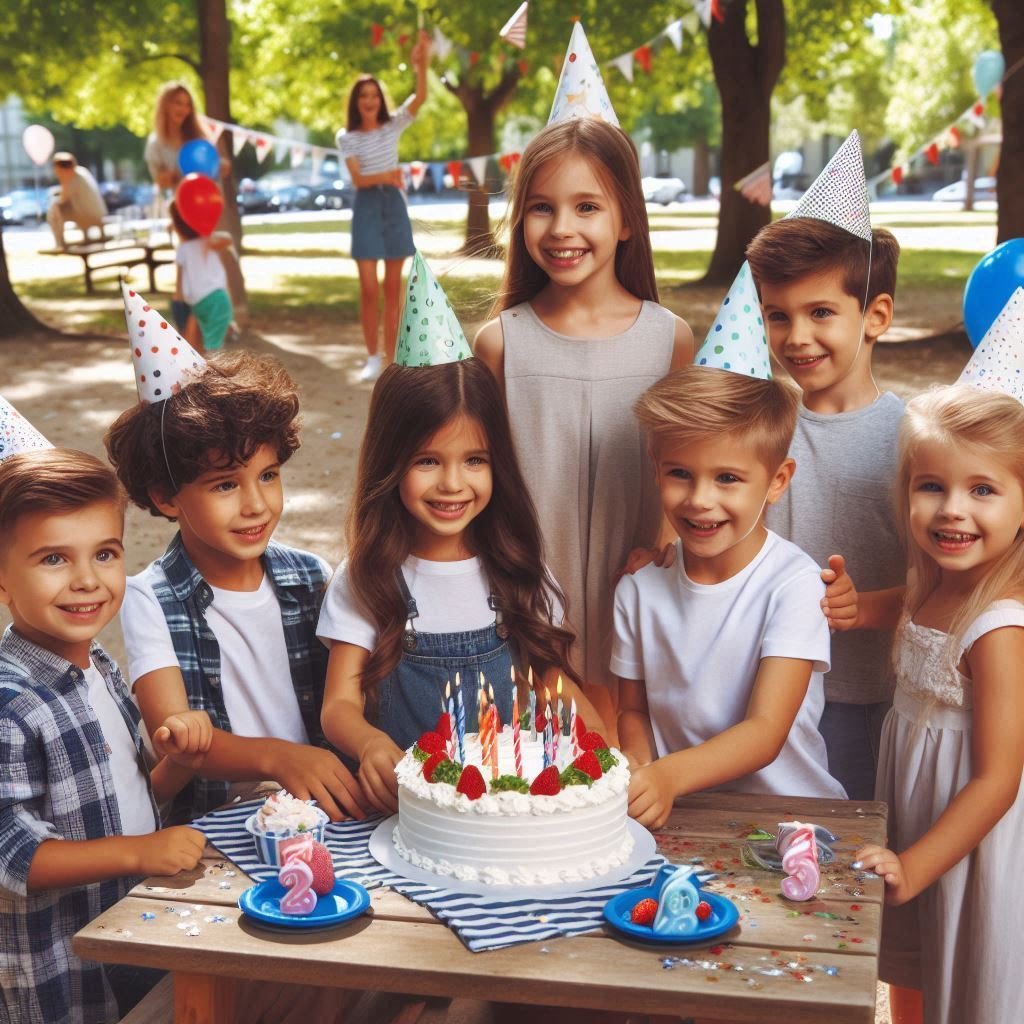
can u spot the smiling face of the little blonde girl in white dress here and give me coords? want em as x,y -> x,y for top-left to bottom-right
907,440 -> 1024,586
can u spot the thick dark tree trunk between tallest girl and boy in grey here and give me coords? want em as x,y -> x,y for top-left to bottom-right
702,0 -> 785,285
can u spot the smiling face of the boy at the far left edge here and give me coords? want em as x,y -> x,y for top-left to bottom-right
0,501 -> 125,668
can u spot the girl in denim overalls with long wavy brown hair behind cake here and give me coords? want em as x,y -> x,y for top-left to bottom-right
317,358 -> 601,811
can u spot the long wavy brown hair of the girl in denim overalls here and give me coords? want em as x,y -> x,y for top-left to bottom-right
347,358 -> 580,700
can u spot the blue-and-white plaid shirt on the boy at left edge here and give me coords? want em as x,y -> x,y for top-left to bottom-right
0,627 -> 160,1024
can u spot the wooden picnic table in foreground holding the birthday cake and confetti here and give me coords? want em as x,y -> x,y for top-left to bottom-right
74,794 -> 886,1024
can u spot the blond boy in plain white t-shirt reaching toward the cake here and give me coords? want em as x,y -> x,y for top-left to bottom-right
611,364 -> 846,827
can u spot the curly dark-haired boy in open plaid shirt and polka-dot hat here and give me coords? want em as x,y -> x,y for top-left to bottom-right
104,293 -> 362,820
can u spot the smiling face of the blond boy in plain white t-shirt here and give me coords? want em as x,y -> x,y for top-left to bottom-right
652,434 -> 795,584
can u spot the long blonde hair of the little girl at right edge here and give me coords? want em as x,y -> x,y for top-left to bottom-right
896,384 -> 1024,668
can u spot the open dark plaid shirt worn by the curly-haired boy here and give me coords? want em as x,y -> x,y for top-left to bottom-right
146,534 -> 328,824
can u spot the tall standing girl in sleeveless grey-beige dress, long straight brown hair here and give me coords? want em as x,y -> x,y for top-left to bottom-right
474,118 -> 693,720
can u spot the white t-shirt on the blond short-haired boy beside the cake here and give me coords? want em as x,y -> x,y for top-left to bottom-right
611,531 -> 846,800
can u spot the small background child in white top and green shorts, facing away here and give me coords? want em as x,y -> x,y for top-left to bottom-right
170,197 -> 233,352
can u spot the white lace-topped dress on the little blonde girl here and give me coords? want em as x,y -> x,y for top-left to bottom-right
876,600 -> 1024,1024
